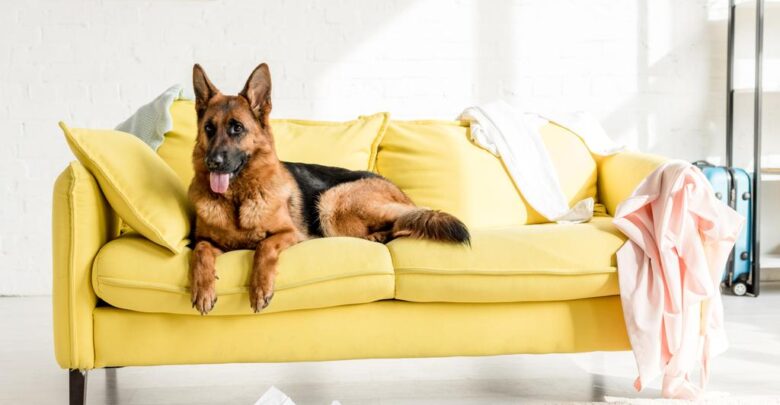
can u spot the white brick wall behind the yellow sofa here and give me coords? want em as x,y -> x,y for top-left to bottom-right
0,0 -> 725,295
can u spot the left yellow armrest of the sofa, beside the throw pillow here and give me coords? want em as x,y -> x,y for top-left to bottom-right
52,162 -> 117,369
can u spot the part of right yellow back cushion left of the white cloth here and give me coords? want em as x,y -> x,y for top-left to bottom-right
377,120 -> 527,227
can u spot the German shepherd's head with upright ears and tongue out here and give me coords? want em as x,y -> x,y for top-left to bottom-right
192,63 -> 274,194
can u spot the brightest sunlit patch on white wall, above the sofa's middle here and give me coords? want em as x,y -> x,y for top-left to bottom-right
304,0 -> 475,118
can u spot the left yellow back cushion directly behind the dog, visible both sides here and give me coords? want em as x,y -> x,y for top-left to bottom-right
157,100 -> 389,187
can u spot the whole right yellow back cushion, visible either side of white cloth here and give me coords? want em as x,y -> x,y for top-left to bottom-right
377,120 -> 596,227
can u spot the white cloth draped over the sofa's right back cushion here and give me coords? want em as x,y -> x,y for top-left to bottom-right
460,101 -> 621,223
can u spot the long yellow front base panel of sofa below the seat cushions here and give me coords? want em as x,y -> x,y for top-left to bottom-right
94,297 -> 630,367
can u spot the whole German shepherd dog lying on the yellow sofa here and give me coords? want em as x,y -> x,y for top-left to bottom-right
189,63 -> 470,315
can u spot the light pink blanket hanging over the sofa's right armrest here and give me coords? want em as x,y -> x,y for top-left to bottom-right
614,161 -> 744,399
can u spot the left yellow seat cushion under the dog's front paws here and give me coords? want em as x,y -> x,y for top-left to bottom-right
92,234 -> 394,315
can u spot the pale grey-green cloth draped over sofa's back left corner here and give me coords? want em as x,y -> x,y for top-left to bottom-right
116,84 -> 192,150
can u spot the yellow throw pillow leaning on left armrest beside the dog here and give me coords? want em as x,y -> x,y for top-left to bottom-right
60,122 -> 192,253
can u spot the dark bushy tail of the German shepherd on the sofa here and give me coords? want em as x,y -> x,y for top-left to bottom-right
393,208 -> 471,245
